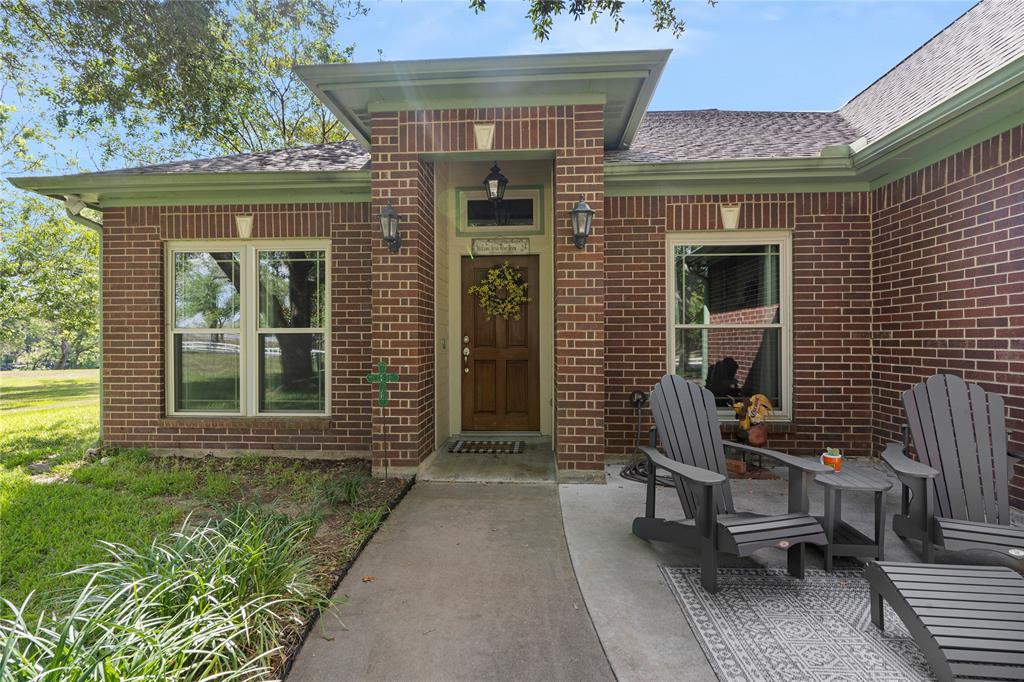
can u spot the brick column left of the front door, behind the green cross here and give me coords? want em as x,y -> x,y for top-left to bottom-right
367,113 -> 434,474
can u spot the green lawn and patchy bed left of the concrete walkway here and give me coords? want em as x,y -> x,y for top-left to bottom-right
0,371 -> 400,614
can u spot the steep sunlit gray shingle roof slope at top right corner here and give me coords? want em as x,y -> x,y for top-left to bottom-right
839,0 -> 1024,142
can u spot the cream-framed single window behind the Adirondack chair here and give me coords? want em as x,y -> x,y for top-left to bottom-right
668,230 -> 793,419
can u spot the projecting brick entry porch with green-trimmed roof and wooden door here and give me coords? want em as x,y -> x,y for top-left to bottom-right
297,51 -> 668,480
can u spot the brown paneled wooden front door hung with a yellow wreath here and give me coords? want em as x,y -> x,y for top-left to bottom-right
460,256 -> 541,431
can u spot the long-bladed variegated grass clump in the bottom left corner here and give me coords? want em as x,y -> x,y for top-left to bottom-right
0,508 -> 328,681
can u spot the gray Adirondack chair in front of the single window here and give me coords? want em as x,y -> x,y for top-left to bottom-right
633,375 -> 831,593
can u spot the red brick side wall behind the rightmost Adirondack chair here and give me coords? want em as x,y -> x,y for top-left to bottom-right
871,126 -> 1024,506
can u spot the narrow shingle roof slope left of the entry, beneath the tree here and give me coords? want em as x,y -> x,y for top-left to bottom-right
94,140 -> 370,175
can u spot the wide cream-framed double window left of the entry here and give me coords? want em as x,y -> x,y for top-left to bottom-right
167,241 -> 330,416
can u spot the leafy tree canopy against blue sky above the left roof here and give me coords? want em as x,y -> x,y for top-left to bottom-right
0,0 -> 366,166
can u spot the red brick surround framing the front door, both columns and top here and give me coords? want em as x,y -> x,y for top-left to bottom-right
372,105 -> 604,475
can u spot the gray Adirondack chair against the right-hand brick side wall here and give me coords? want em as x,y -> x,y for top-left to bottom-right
882,374 -> 1024,566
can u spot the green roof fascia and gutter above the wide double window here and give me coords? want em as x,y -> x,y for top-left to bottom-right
9,170 -> 370,208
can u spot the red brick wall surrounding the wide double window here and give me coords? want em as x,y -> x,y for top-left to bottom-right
96,204 -> 373,454
